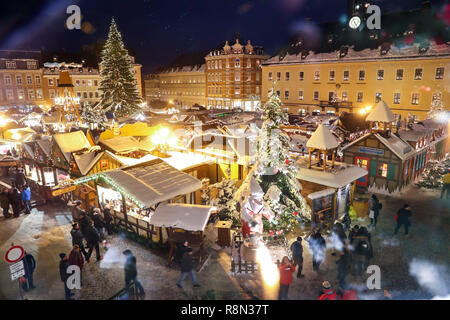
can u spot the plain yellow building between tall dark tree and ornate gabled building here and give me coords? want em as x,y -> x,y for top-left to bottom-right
158,64 -> 206,108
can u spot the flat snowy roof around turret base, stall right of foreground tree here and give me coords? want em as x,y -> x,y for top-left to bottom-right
296,157 -> 367,188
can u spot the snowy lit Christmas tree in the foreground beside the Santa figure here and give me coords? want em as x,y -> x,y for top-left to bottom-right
238,90 -> 311,236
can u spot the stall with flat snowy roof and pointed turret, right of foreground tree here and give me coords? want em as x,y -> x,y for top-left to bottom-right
296,124 -> 367,229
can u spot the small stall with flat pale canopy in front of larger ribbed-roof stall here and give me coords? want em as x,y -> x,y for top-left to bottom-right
150,203 -> 216,270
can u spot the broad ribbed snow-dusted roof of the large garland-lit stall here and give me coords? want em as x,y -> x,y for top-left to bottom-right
102,159 -> 202,208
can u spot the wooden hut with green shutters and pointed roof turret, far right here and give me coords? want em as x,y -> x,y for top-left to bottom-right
342,101 -> 447,194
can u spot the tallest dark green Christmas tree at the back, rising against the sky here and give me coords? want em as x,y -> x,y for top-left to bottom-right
99,19 -> 142,116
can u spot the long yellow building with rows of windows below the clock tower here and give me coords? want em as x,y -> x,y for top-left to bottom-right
262,43 -> 450,119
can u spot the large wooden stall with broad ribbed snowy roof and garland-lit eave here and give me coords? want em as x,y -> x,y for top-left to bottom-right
75,159 -> 202,244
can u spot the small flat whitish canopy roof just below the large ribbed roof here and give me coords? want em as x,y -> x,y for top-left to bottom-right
149,203 -> 216,231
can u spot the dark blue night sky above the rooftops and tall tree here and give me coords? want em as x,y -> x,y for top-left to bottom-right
0,0 -> 444,72
